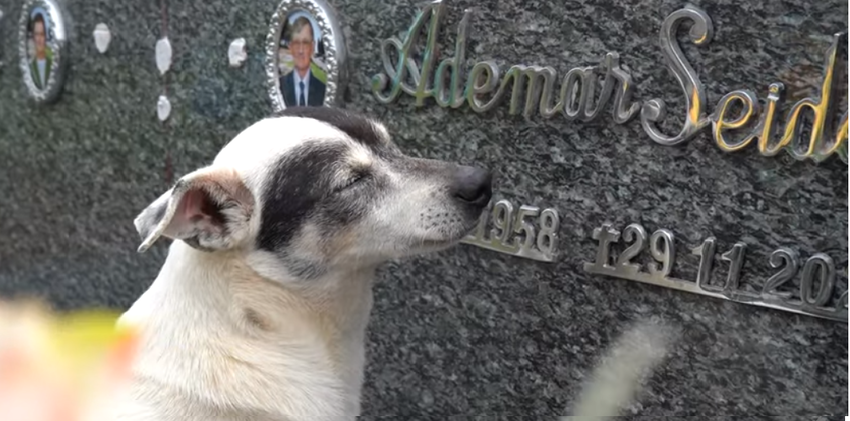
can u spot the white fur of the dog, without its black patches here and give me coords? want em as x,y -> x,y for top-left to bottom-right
111,110 -> 489,421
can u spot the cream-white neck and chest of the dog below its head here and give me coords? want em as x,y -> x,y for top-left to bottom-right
122,241 -> 374,419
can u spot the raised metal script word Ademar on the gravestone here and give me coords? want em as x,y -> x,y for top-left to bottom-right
372,0 -> 640,124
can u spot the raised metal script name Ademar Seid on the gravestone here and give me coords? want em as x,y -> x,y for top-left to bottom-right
372,0 -> 848,163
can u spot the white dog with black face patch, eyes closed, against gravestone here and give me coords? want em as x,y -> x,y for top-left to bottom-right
115,107 -> 493,421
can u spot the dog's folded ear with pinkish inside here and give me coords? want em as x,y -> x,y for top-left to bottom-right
133,167 -> 254,253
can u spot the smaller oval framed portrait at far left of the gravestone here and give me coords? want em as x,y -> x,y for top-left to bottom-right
18,0 -> 70,103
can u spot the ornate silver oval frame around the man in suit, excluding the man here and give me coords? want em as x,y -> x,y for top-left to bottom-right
265,0 -> 346,112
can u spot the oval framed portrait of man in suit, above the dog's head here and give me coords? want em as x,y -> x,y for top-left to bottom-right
265,0 -> 345,112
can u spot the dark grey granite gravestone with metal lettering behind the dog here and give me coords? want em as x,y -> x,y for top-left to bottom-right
0,0 -> 848,420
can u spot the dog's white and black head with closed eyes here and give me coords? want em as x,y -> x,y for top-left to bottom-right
135,107 -> 491,278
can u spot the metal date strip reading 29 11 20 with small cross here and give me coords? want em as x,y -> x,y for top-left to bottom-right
584,224 -> 847,323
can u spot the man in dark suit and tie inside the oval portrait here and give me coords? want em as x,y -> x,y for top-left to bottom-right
280,16 -> 325,107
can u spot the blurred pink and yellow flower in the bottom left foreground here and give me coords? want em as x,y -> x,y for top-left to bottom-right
0,302 -> 139,421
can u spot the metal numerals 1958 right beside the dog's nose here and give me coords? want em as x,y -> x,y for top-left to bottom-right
461,200 -> 561,262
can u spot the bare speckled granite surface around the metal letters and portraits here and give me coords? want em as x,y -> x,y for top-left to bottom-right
0,0 -> 848,420
